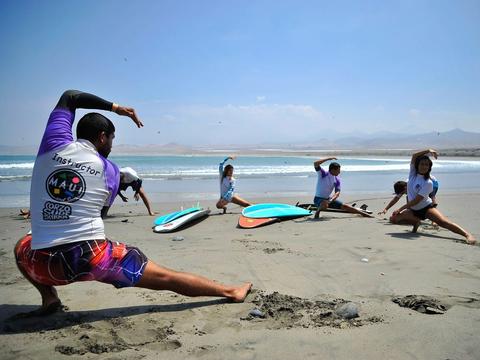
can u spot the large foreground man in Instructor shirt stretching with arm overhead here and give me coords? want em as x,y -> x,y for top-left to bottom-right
14,90 -> 252,316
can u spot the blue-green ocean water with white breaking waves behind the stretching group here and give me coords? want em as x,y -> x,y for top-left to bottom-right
0,156 -> 480,207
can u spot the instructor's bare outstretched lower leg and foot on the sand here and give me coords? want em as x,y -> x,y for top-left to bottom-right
136,261 -> 252,302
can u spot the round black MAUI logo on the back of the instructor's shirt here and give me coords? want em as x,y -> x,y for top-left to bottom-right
46,169 -> 86,203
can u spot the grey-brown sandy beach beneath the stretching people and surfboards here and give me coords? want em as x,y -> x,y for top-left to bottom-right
0,192 -> 480,359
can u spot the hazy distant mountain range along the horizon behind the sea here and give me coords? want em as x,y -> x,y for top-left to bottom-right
0,129 -> 480,155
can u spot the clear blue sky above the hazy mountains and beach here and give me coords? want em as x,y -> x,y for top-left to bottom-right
0,0 -> 480,146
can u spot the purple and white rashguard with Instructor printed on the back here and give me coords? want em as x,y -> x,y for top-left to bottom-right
30,91 -> 120,249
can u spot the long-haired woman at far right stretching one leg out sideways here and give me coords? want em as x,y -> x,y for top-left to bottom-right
390,149 -> 475,245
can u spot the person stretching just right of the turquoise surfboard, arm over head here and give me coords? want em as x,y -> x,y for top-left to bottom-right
313,157 -> 373,219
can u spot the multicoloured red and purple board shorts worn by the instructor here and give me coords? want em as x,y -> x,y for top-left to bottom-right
15,235 -> 148,288
